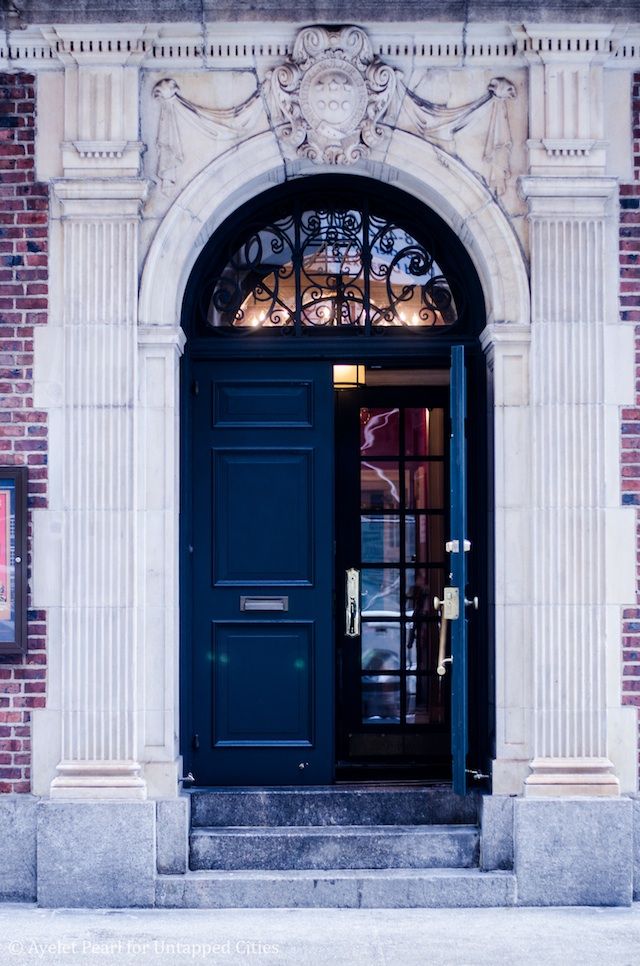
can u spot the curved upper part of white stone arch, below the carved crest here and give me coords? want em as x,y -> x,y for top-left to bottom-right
139,131 -> 530,326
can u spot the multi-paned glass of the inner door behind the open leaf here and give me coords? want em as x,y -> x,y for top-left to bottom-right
358,406 -> 446,728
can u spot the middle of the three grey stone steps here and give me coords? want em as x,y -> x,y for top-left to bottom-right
190,825 -> 479,870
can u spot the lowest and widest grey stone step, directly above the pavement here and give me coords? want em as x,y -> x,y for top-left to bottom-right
156,869 -> 516,909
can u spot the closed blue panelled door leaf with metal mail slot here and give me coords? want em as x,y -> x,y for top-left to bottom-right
188,361 -> 334,785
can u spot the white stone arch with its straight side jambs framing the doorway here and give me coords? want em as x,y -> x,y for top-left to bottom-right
139,131 -> 531,795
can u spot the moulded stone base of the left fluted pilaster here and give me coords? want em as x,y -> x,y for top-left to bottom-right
50,761 -> 147,801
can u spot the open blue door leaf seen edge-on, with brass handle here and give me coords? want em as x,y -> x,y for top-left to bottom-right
447,346 -> 469,795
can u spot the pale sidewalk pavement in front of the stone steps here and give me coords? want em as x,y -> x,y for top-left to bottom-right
0,904 -> 640,966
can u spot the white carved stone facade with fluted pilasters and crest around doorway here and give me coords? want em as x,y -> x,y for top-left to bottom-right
0,13 -> 640,799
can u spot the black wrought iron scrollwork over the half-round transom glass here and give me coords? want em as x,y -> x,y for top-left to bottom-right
203,200 -> 460,332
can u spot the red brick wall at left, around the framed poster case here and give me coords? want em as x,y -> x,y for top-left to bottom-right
0,73 -> 49,792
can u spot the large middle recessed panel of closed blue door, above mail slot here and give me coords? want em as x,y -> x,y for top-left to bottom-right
213,448 -> 314,586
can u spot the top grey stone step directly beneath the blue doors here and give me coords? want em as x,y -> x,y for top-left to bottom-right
191,785 -> 479,828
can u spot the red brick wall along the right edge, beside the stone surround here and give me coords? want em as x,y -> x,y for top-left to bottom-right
620,73 -> 640,784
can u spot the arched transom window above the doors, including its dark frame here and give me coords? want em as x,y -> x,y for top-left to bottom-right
184,175 -> 484,340
